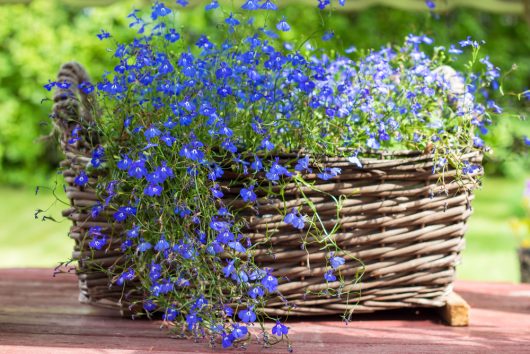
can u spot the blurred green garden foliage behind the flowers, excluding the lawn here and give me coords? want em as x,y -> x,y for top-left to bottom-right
0,0 -> 530,185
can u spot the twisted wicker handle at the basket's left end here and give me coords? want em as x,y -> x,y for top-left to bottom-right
53,62 -> 95,149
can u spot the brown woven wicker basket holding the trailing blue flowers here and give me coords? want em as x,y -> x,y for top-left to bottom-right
54,63 -> 481,315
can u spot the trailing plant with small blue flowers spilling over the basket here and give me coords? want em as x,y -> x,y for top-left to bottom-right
46,0 -> 506,347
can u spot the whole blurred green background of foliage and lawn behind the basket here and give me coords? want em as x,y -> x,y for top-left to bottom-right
0,0 -> 530,281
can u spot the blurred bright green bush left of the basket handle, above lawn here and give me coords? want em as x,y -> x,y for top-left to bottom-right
0,0 -> 139,185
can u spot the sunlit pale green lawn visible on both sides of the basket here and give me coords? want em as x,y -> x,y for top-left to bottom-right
0,178 -> 524,282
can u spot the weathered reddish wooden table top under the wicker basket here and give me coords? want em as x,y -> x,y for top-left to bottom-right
0,269 -> 530,354
